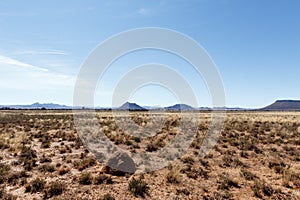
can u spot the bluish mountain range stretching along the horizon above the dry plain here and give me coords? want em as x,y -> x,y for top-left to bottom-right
0,100 -> 300,111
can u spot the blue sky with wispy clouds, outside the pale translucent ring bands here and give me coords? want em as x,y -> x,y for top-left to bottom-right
0,0 -> 300,108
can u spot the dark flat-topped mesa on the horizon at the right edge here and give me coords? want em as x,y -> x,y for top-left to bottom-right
262,100 -> 300,110
